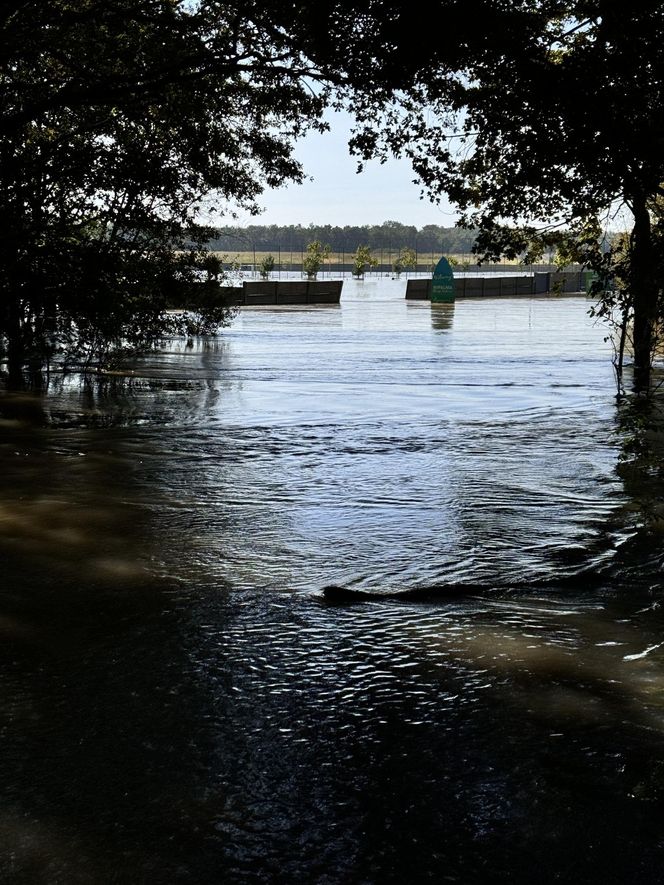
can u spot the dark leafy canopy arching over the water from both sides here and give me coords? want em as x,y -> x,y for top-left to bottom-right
5,0 -> 664,384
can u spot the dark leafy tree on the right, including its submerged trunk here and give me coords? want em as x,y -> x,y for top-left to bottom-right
342,0 -> 664,389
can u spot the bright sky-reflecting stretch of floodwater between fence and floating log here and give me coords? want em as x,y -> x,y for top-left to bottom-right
137,281 -> 620,590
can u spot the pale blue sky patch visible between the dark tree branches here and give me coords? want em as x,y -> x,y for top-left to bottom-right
250,114 -> 458,227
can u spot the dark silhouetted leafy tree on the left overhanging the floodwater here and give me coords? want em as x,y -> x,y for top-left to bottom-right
0,0 -> 332,383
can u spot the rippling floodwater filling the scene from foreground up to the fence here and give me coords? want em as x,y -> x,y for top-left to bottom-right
0,282 -> 664,885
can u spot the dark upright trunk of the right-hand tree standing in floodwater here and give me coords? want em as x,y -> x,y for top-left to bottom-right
630,197 -> 657,393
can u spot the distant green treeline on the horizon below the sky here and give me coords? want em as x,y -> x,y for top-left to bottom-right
210,221 -> 475,255
